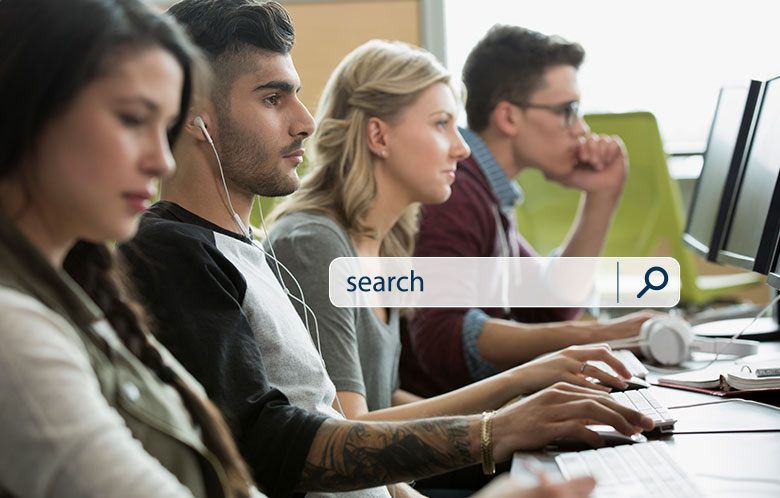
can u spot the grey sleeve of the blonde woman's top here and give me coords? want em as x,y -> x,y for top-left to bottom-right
263,216 -> 366,397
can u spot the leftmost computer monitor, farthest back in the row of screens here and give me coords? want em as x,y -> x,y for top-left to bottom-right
682,81 -> 761,261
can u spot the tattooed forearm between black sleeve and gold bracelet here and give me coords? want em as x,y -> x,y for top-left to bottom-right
298,417 -> 480,491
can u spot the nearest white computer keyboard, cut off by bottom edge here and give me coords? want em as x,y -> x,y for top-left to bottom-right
555,441 -> 704,498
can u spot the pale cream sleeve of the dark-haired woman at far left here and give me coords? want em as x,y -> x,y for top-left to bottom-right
0,289 -> 192,498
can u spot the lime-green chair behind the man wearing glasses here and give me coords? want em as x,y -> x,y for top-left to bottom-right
517,112 -> 763,305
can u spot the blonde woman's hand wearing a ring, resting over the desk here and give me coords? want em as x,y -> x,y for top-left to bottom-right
506,344 -> 631,393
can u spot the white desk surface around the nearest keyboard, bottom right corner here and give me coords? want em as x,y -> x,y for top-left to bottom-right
512,344 -> 780,498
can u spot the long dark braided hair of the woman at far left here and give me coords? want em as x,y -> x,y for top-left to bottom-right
0,0 -> 251,496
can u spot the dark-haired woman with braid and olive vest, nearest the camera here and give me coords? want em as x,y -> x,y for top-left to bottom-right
0,0 -> 256,497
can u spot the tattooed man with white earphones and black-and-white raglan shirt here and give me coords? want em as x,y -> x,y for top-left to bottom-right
121,6 -> 652,497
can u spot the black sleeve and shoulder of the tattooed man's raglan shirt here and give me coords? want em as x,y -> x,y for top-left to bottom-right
119,202 -> 325,497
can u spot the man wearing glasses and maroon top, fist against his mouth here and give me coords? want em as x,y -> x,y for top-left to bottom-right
401,25 -> 650,396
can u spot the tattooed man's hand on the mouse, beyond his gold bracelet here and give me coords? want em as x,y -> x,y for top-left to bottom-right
492,382 -> 653,461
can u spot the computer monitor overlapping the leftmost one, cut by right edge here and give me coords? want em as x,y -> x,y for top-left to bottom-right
717,77 -> 780,274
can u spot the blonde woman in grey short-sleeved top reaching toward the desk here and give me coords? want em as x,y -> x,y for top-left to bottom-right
264,40 -> 640,428
